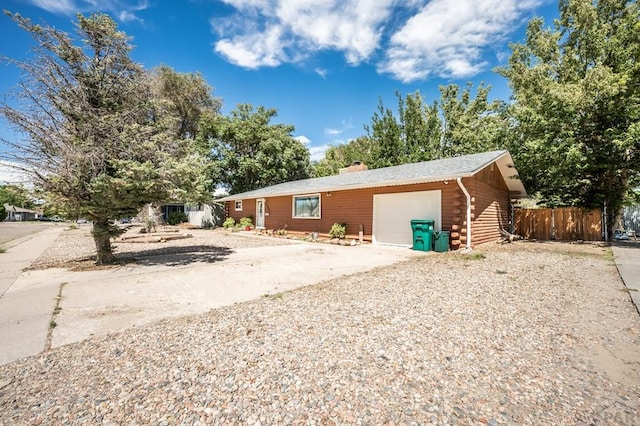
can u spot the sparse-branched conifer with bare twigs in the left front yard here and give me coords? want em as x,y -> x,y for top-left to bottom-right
0,13 -> 207,264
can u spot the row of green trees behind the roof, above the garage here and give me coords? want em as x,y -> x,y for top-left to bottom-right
322,84 -> 511,176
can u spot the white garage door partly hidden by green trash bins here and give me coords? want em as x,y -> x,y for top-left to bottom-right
373,190 -> 442,245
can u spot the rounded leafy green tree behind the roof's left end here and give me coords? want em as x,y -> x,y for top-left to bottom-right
198,104 -> 311,194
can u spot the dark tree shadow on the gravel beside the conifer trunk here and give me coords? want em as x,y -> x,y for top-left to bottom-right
116,246 -> 233,266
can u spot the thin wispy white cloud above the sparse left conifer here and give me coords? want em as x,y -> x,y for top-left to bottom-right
28,0 -> 149,22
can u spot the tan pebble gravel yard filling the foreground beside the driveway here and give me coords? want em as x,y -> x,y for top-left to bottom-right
0,240 -> 640,425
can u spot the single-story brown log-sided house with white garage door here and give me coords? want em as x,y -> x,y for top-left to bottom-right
218,151 -> 527,249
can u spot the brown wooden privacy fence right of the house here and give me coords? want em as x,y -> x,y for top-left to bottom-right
514,207 -> 602,241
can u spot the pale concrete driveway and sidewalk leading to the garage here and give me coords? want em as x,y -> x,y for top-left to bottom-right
0,231 -> 428,364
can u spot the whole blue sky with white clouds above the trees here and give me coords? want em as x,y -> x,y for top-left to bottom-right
0,0 -> 557,181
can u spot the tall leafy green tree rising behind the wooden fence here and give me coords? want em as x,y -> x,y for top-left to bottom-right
499,0 -> 640,231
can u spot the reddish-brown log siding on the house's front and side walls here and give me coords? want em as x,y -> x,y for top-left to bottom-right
226,162 -> 509,250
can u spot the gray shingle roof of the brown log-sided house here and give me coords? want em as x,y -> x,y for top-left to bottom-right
218,150 -> 526,201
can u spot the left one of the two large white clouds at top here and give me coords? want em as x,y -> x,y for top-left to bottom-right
212,0 -> 393,68
